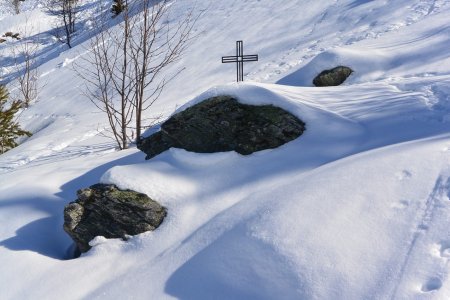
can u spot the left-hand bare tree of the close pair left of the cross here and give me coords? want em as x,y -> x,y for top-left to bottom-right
74,3 -> 134,150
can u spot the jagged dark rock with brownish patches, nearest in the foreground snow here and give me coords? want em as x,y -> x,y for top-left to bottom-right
64,184 -> 166,252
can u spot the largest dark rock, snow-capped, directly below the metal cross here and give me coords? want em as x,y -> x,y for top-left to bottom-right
138,96 -> 305,159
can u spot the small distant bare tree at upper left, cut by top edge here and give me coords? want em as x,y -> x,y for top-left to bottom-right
45,0 -> 78,48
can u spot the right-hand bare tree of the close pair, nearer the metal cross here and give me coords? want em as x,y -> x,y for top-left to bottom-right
130,0 -> 195,143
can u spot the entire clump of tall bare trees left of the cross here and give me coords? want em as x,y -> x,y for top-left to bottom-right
75,0 -> 195,149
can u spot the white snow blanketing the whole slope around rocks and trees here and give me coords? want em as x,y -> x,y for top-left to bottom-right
0,0 -> 450,299
